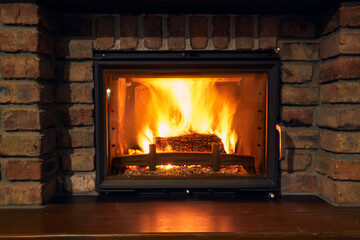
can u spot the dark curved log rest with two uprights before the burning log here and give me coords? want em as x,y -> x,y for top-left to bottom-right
112,144 -> 254,173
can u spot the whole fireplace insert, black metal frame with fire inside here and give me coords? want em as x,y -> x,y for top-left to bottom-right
94,51 -> 280,191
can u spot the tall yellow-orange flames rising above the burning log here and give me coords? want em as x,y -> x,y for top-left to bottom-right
132,78 -> 240,153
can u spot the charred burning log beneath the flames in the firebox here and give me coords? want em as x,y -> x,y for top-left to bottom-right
155,133 -> 225,153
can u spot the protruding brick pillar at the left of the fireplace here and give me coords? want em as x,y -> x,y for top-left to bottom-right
0,3 -> 59,205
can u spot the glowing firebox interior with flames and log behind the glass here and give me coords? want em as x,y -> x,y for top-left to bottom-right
105,69 -> 268,178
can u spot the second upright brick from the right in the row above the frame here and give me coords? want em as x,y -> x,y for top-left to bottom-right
235,16 -> 254,49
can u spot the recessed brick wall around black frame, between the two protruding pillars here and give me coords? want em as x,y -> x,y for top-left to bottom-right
57,12 -> 320,197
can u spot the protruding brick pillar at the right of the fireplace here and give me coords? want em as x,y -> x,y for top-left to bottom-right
314,3 -> 360,204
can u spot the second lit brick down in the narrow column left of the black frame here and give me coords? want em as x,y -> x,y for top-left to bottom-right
64,62 -> 93,82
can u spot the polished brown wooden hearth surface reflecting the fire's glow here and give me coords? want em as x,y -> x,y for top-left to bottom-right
0,196 -> 360,240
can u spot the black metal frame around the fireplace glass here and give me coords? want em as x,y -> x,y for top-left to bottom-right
94,51 -> 280,192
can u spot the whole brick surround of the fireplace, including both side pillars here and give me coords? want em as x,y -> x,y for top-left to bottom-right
0,0 -> 360,204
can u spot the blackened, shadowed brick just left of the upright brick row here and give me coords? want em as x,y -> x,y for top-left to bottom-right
60,15 -> 93,37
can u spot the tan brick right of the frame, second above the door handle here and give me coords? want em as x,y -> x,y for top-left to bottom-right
281,85 -> 318,105
